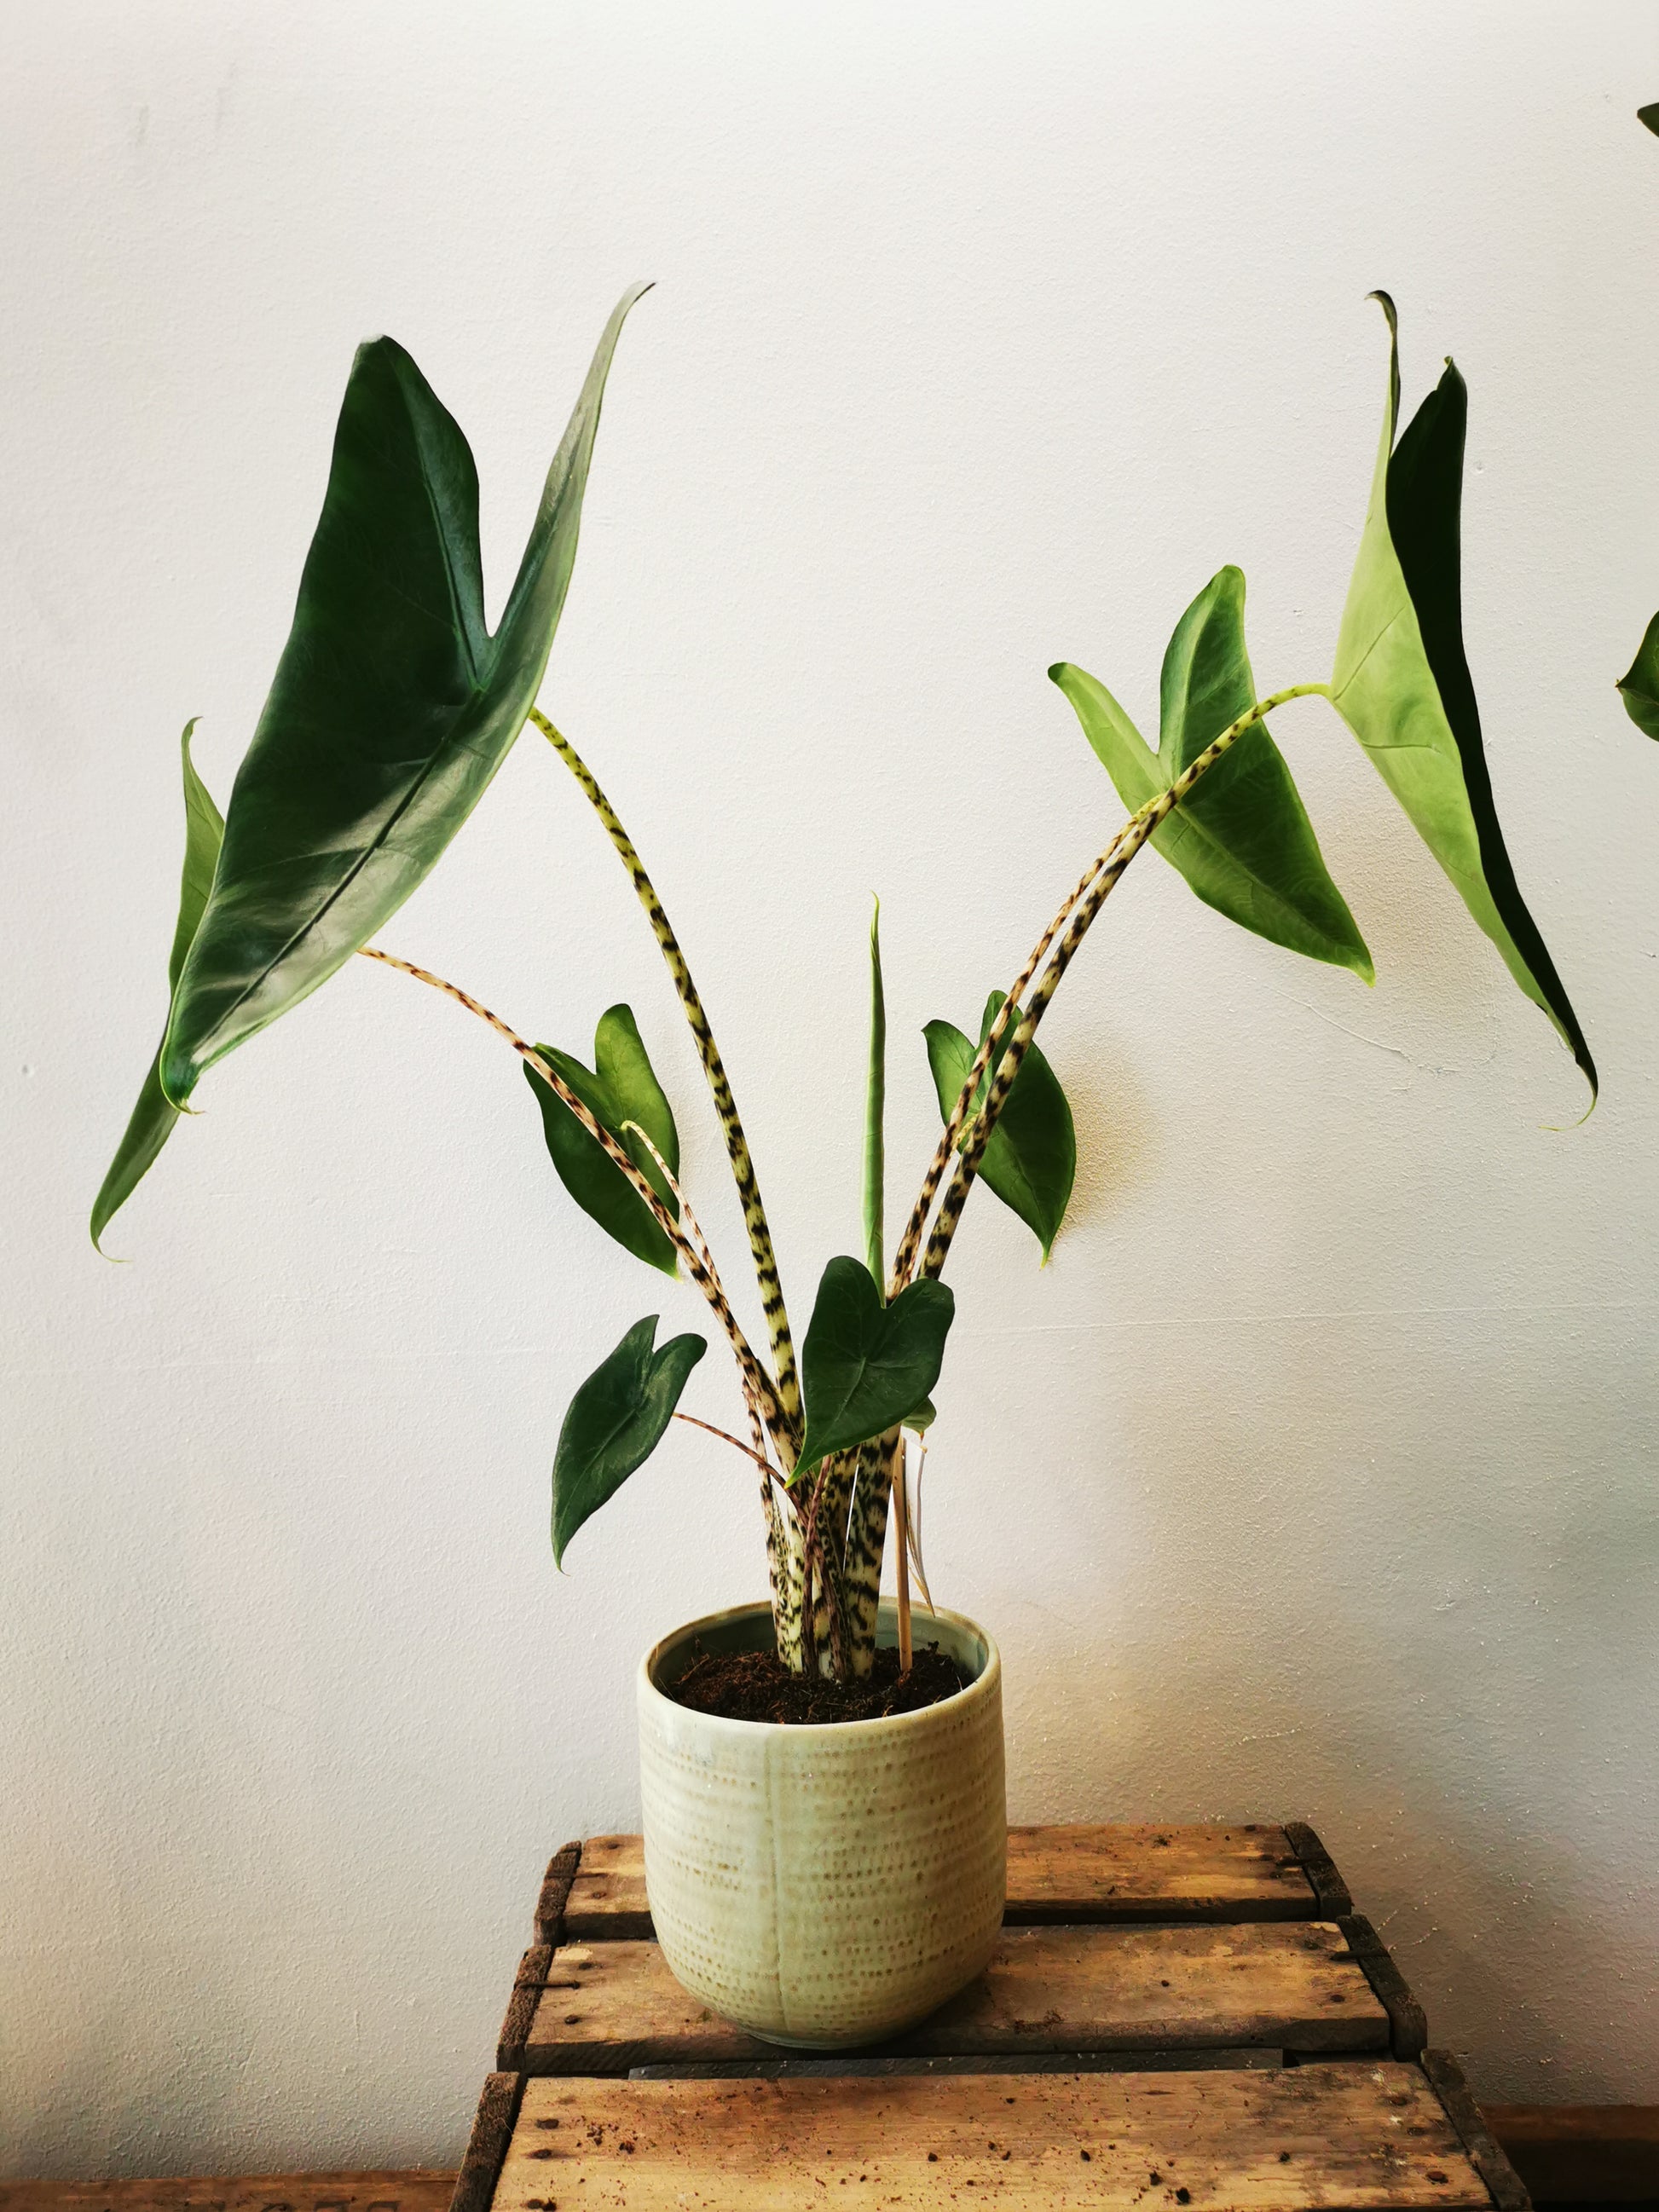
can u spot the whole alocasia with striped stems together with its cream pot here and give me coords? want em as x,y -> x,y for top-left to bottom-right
93,287 -> 1595,2044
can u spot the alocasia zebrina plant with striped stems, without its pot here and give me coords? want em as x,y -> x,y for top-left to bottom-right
93,292 -> 1595,1679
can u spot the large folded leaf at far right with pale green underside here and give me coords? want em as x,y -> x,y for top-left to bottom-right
1332,305 -> 1597,1097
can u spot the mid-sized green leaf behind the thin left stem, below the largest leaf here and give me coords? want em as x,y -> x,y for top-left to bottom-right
520,1007 -> 679,1274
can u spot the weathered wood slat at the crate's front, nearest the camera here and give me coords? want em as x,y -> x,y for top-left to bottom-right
495,2062 -> 1491,2212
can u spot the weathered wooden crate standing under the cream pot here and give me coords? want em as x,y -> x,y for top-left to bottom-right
454,1822 -> 1526,2212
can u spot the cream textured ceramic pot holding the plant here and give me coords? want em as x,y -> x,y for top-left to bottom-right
639,1606 -> 1009,2051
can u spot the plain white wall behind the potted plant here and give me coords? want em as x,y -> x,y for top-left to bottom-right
0,0 -> 1659,2174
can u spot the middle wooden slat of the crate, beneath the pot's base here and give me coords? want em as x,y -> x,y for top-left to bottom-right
517,1920 -> 1389,2075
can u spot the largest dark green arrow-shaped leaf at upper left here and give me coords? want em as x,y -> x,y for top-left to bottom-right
161,287 -> 644,1123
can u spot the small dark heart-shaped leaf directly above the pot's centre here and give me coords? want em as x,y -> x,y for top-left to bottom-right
792,1256 -> 956,1480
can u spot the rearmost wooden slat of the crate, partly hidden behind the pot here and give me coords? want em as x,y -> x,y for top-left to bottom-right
559,1822 -> 1354,1942
